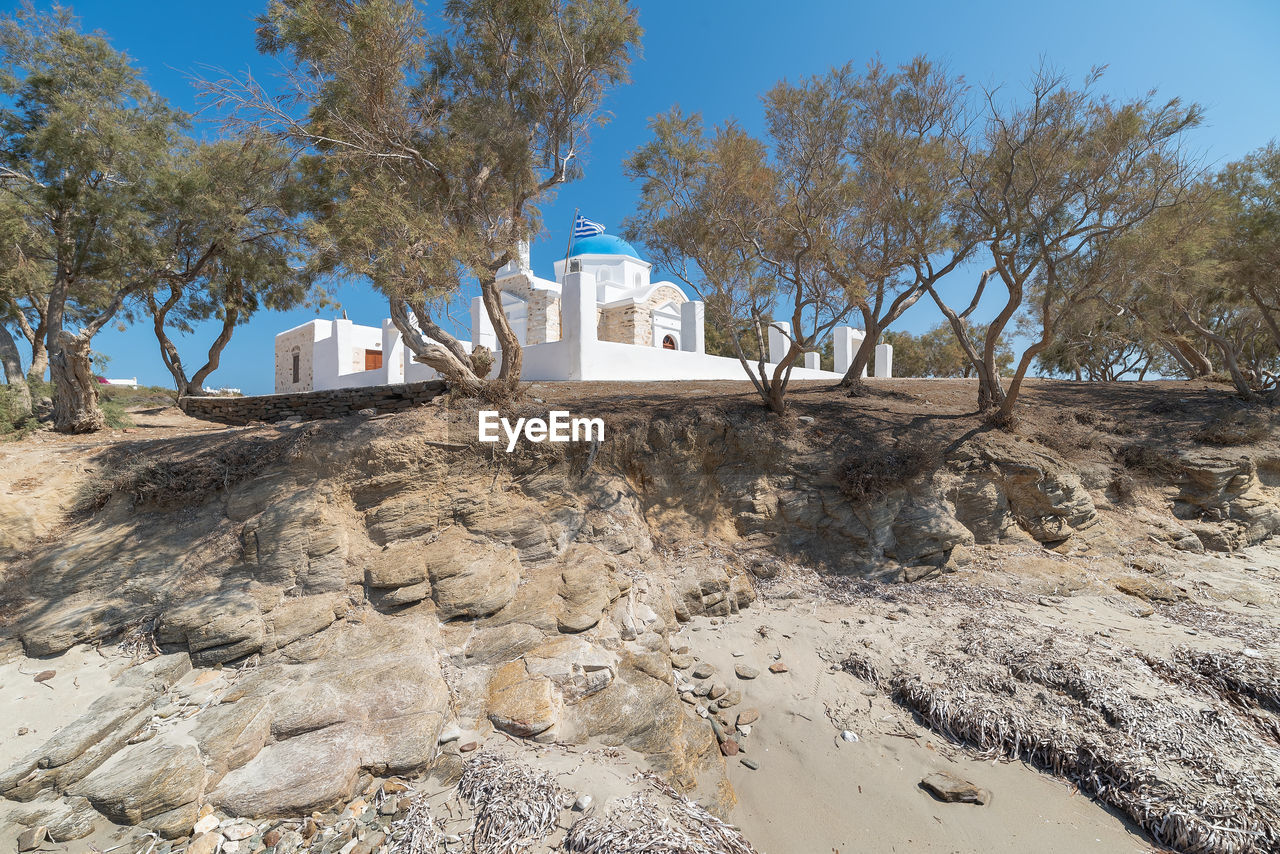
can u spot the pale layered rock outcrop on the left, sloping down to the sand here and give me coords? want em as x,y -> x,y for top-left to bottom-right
0,414 -> 753,839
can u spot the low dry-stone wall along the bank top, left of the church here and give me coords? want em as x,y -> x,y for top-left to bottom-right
178,380 -> 444,426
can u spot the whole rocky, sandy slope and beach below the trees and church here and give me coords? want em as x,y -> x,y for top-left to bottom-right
0,380 -> 1280,854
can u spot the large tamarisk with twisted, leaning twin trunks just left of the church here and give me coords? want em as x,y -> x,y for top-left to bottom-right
205,0 -> 640,394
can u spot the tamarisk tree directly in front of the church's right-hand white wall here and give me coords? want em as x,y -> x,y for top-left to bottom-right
625,96 -> 864,412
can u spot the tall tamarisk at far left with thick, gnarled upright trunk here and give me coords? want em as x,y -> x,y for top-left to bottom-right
0,4 -> 184,433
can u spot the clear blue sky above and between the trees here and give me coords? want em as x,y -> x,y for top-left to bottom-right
9,0 -> 1280,393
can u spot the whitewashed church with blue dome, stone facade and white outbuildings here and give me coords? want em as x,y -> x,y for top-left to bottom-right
275,230 -> 893,394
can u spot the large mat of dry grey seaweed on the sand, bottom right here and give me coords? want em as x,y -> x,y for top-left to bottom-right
842,604 -> 1280,854
